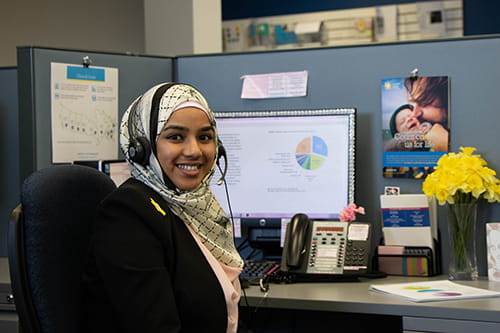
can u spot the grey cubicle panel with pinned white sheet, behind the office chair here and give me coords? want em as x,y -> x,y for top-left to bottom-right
17,47 -> 174,180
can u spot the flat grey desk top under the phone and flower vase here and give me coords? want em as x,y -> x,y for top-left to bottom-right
242,276 -> 500,323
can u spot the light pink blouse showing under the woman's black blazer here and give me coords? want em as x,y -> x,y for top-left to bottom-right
188,226 -> 241,333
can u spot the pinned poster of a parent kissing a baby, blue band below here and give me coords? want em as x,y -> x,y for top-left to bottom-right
381,76 -> 450,179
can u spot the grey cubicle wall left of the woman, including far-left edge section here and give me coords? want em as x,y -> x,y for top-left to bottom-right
0,47 -> 174,257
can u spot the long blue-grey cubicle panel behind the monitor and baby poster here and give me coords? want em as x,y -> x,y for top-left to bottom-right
176,36 -> 500,275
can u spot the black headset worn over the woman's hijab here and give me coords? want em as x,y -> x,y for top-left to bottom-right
127,82 -> 227,185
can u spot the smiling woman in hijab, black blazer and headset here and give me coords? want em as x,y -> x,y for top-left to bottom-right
84,83 -> 247,333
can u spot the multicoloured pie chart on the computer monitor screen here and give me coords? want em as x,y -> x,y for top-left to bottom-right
295,136 -> 328,170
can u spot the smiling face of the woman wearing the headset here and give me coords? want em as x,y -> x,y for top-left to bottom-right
156,107 -> 215,191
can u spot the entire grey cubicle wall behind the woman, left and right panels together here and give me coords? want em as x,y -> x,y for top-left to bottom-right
6,36 -> 500,275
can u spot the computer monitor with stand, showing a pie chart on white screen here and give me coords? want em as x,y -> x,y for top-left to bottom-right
211,108 -> 356,256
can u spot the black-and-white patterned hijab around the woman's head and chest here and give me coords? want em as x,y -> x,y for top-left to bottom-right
120,83 -> 243,267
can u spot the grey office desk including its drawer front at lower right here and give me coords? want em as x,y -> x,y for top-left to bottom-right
242,276 -> 500,333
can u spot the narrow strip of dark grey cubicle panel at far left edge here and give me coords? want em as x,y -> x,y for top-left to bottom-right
0,67 -> 19,257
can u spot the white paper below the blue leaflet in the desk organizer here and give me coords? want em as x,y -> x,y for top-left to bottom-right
382,227 -> 434,250
